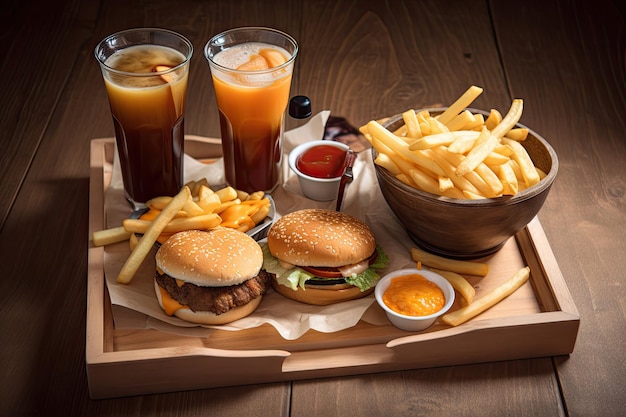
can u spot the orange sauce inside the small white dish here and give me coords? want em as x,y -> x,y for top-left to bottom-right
383,274 -> 446,316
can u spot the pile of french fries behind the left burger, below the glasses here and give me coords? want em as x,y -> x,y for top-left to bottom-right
91,179 -> 271,284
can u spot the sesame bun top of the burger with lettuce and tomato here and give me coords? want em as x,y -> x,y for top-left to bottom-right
267,209 -> 376,267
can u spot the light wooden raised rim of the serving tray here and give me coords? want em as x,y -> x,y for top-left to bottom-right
85,135 -> 580,398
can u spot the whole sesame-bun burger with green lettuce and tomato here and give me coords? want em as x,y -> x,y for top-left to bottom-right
263,209 -> 388,305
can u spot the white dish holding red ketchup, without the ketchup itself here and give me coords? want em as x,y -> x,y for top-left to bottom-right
288,140 -> 349,201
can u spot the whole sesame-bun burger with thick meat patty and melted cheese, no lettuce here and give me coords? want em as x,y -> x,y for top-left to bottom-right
154,227 -> 270,324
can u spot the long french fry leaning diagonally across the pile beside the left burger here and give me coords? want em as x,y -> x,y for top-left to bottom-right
117,187 -> 191,284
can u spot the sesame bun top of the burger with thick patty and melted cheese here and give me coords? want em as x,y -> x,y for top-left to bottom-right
155,227 -> 263,287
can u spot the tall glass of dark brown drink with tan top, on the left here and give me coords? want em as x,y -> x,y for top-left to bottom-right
95,28 -> 193,208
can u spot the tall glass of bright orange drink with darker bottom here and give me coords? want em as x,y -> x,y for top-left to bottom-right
204,27 -> 298,192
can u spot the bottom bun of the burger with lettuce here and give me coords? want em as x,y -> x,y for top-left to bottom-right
272,277 -> 374,306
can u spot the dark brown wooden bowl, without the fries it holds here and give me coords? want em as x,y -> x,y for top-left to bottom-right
372,108 -> 559,259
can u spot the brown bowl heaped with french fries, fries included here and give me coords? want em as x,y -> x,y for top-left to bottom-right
361,86 -> 558,259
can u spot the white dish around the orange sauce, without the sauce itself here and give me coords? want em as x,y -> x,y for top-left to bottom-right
374,268 -> 455,332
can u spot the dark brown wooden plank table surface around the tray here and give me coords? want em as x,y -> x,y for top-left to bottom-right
0,0 -> 626,416
